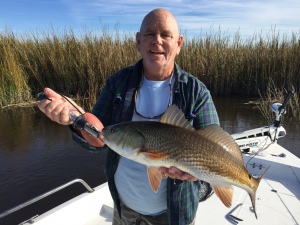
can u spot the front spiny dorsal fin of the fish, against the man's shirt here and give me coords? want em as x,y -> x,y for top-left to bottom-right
159,105 -> 194,130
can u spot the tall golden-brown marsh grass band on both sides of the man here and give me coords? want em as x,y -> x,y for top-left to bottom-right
0,27 -> 300,118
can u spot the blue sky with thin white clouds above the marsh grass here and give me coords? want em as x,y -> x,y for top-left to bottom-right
0,0 -> 300,37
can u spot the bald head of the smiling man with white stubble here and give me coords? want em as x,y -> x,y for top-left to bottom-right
136,9 -> 183,80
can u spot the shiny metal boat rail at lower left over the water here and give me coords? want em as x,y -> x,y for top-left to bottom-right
0,179 -> 94,219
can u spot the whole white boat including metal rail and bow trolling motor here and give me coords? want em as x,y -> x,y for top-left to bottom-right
0,92 -> 300,225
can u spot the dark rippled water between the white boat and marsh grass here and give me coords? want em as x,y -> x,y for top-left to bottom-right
0,98 -> 300,224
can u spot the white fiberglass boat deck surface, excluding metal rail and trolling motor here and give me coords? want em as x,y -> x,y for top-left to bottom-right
24,143 -> 300,225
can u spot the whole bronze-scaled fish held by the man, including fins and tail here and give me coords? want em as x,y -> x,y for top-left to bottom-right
102,105 -> 266,217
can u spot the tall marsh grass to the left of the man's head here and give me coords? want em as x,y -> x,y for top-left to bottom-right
0,28 -> 139,106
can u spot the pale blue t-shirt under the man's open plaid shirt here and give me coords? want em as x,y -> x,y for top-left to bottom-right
114,76 -> 174,215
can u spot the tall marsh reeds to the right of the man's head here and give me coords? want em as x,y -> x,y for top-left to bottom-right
178,30 -> 300,96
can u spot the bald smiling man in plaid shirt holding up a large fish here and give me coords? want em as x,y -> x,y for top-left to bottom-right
38,9 -> 219,225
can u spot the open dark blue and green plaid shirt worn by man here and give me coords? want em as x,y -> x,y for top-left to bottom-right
73,60 -> 219,225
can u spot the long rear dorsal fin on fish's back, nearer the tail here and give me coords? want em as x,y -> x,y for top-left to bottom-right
197,124 -> 244,163
